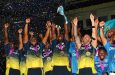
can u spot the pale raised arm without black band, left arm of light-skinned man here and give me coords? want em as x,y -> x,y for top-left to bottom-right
73,17 -> 81,49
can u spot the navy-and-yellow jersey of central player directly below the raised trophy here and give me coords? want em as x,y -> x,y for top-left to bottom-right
52,40 -> 70,70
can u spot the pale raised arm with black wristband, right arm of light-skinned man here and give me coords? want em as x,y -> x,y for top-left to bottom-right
90,14 -> 97,48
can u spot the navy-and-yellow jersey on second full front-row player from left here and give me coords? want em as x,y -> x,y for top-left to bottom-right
24,42 -> 43,68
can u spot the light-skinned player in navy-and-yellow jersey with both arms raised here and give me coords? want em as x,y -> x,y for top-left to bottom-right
73,14 -> 97,75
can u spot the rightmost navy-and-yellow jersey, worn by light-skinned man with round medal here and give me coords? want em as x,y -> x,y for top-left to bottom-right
78,44 -> 96,73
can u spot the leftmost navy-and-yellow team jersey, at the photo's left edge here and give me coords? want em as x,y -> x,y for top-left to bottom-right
4,44 -> 19,75
